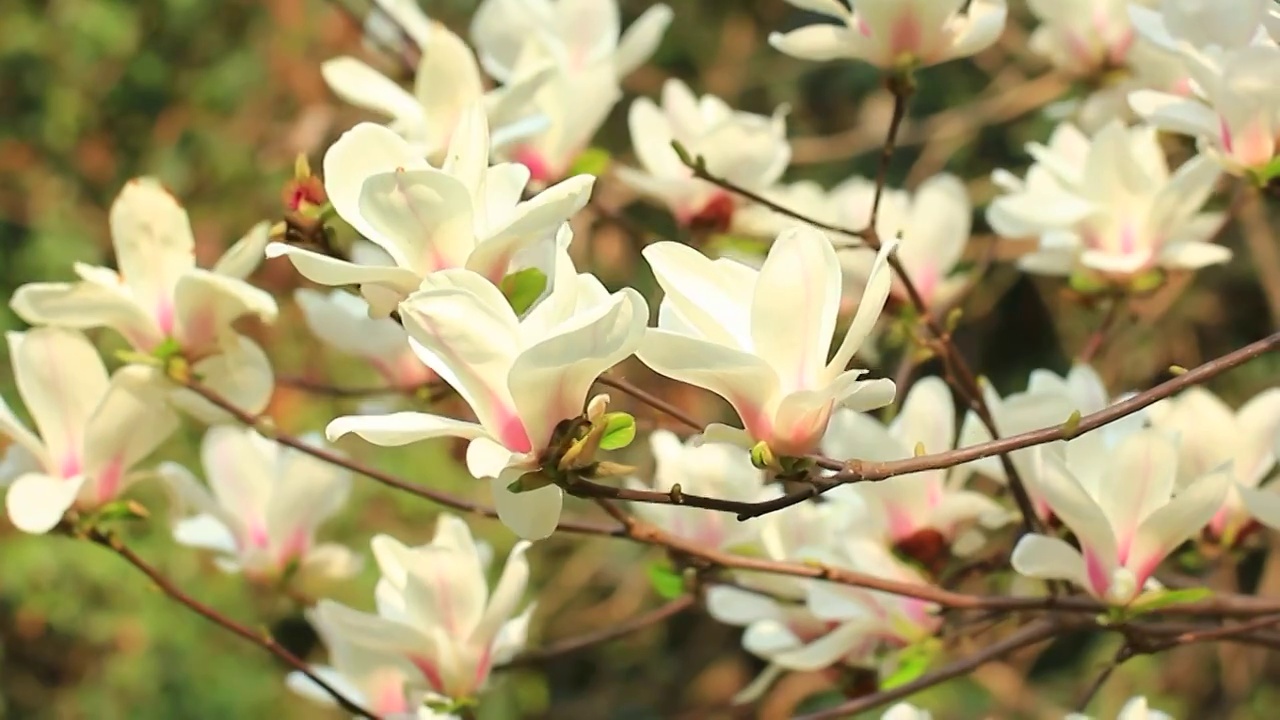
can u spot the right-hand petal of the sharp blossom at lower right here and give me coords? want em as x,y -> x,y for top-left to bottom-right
1125,469 -> 1231,587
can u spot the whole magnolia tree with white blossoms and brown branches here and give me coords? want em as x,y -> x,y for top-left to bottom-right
0,0 -> 1280,720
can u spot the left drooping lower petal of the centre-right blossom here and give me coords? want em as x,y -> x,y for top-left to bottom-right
636,327 -> 778,441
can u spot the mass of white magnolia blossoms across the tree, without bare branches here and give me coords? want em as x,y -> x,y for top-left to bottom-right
0,0 -> 1280,720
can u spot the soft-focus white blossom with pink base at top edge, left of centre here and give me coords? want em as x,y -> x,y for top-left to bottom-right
471,0 -> 672,184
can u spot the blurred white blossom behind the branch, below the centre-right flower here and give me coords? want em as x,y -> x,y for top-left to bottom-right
628,429 -> 768,548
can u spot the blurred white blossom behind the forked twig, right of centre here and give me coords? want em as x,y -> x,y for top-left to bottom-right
831,173 -> 973,307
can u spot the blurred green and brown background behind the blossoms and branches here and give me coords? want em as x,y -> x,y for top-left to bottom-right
0,0 -> 1280,720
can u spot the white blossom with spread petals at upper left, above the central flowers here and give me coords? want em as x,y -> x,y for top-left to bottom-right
320,21 -> 550,160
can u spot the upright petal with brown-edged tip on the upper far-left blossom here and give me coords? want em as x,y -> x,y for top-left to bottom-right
110,178 -> 196,311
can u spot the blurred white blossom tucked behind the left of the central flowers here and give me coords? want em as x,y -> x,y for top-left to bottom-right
293,288 -> 435,389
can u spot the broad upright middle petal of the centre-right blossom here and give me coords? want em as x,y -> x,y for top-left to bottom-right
751,225 -> 842,392
